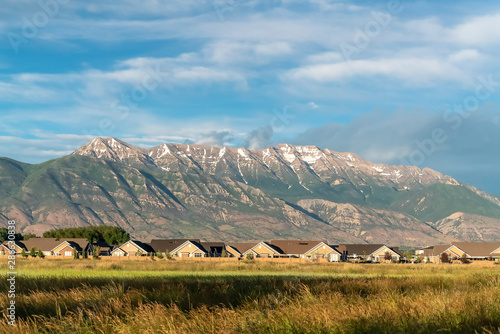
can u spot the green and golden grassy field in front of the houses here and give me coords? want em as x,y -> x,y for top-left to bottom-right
0,259 -> 500,333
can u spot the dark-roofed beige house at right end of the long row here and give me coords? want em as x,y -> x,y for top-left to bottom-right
337,244 -> 401,262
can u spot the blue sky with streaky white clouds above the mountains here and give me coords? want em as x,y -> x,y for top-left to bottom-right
0,0 -> 500,195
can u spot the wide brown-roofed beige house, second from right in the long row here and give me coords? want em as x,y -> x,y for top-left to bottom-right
269,240 -> 341,262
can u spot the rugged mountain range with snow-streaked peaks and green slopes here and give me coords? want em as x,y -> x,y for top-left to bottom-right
0,138 -> 500,246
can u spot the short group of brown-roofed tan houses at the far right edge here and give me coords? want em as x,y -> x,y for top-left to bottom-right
415,242 -> 500,263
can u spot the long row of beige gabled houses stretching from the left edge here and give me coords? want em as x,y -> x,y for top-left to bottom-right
0,238 -> 401,262
